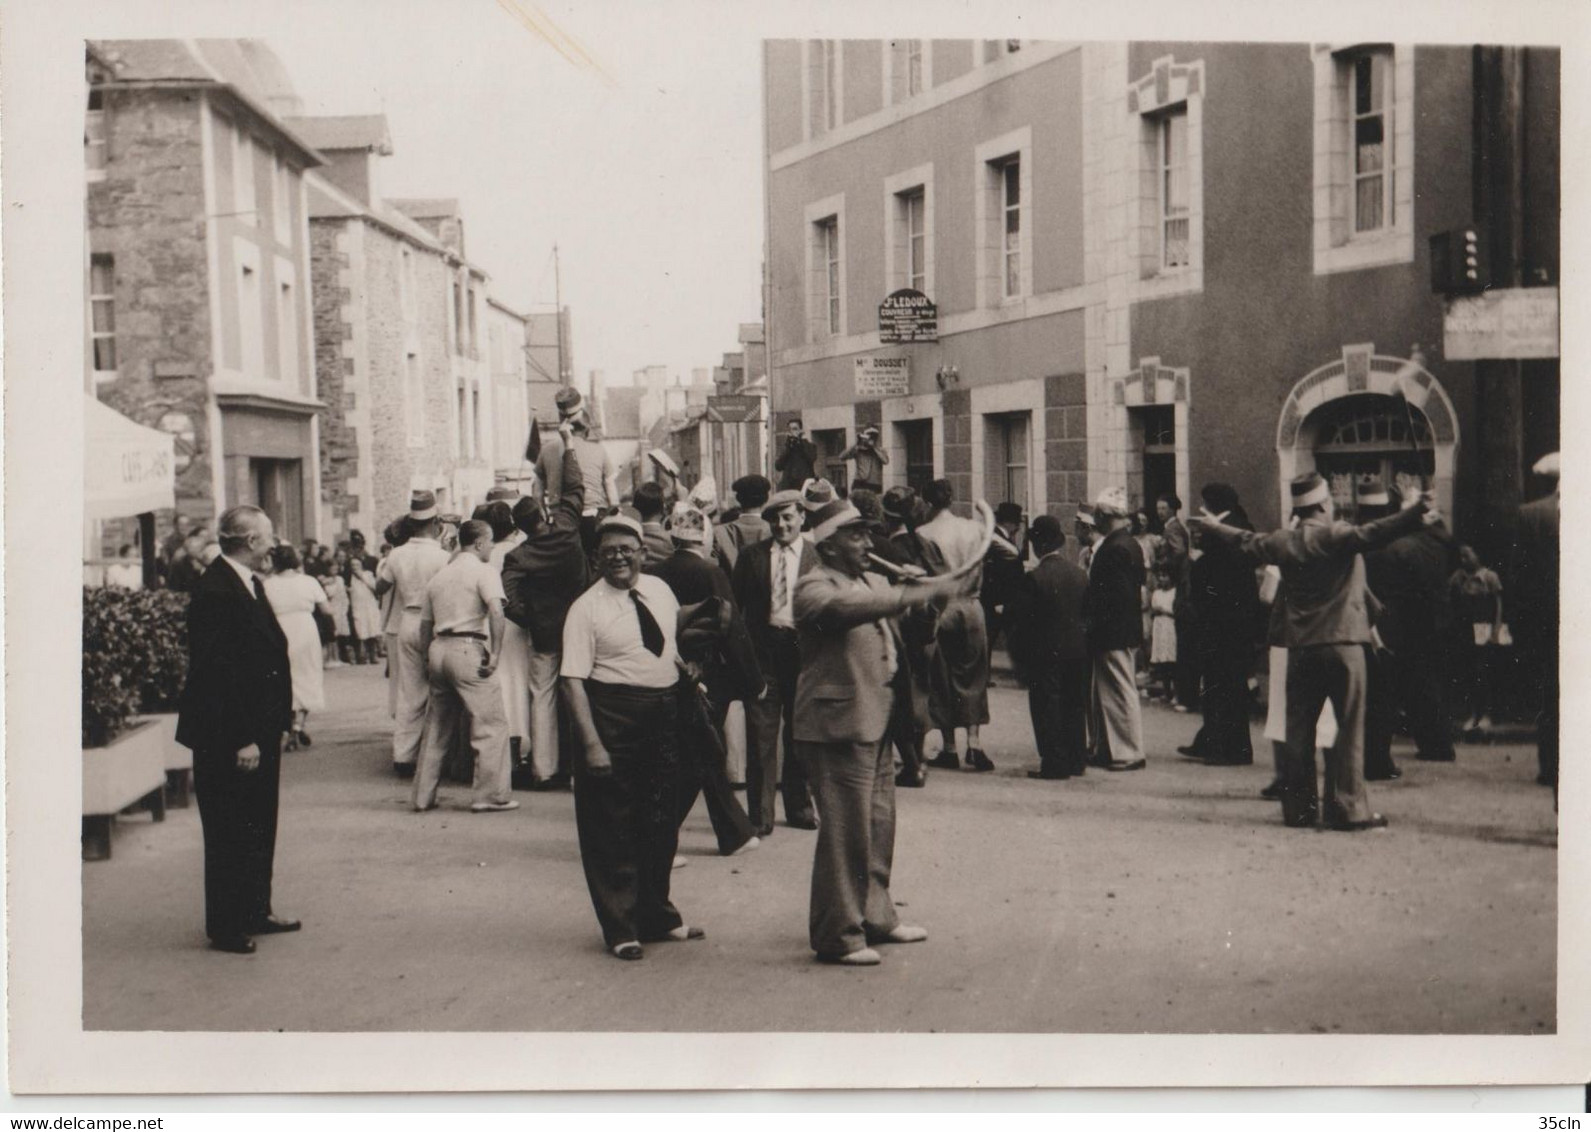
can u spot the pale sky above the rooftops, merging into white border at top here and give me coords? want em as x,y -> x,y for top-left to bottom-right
259,0 -> 762,397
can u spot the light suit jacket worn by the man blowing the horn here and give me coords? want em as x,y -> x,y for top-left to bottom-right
796,566 -> 905,742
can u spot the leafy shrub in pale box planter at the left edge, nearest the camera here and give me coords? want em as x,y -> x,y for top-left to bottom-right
83,587 -> 165,860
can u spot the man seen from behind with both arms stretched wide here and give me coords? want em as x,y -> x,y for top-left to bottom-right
1193,472 -> 1429,832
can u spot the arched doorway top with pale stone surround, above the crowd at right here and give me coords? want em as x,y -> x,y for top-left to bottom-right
1276,347 -> 1459,521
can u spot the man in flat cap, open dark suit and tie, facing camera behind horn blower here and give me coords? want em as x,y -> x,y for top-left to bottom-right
733,491 -> 818,836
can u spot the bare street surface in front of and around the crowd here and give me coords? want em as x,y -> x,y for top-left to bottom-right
83,666 -> 1556,1033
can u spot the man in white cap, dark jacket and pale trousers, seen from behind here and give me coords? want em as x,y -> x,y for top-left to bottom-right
1085,488 -> 1144,771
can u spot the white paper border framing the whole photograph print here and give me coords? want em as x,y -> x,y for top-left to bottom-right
12,0 -> 1591,1094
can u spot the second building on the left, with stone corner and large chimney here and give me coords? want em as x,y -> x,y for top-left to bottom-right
293,116 -> 495,544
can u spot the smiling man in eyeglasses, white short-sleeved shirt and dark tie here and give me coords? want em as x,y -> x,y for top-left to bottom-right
562,514 -> 705,959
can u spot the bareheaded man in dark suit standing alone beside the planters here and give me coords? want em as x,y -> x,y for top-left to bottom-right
177,506 -> 299,956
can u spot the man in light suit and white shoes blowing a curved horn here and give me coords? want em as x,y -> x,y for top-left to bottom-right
796,499 -> 967,967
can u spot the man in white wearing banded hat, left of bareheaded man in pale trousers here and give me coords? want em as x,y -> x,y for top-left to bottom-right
377,490 -> 450,777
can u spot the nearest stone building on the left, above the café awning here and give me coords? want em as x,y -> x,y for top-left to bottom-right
84,40 -> 321,539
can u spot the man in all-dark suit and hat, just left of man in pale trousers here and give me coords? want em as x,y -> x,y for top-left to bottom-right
1007,515 -> 1091,779
